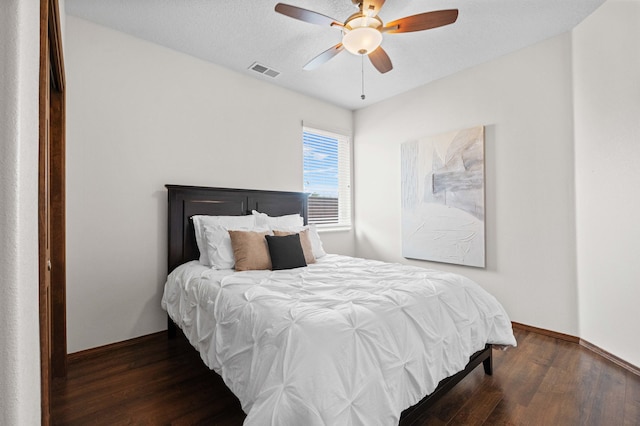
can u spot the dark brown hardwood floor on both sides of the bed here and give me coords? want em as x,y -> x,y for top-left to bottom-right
53,329 -> 640,426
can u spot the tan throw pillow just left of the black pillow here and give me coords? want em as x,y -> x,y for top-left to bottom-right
229,231 -> 271,271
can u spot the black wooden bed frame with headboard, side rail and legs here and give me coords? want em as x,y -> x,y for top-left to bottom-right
166,185 -> 493,426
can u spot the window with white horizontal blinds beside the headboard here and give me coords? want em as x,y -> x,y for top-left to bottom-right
302,127 -> 351,227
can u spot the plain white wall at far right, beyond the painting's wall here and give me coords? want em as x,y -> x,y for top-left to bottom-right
573,0 -> 640,366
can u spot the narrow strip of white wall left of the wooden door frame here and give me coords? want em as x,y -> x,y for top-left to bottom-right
0,0 -> 40,425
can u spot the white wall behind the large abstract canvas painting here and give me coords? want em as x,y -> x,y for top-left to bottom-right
354,34 -> 578,335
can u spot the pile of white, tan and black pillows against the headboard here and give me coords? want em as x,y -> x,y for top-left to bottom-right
191,210 -> 326,271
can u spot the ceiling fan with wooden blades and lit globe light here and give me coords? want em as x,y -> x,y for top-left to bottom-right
275,0 -> 458,73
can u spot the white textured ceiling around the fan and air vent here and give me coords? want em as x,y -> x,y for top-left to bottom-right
65,0 -> 604,109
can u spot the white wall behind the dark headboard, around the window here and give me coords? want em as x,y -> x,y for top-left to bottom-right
65,16 -> 355,352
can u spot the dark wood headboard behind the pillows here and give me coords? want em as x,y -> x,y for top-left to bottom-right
165,185 -> 309,272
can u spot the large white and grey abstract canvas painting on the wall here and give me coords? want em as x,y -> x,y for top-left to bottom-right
401,126 -> 485,267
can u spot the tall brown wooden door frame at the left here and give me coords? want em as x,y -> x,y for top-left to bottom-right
38,0 -> 67,425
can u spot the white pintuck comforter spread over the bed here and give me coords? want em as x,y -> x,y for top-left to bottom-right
162,255 -> 516,426
